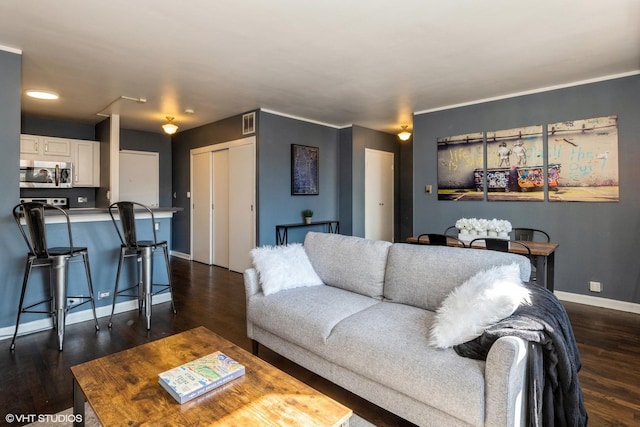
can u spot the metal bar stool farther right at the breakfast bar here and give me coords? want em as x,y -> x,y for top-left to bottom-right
109,202 -> 176,330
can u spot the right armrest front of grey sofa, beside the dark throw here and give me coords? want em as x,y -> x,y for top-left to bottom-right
485,336 -> 529,426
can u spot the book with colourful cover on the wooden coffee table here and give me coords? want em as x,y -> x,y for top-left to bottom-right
158,351 -> 245,404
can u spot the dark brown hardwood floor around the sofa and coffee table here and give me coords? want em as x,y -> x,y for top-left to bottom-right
0,257 -> 640,426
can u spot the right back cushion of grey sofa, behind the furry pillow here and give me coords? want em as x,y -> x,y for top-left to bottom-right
382,243 -> 531,311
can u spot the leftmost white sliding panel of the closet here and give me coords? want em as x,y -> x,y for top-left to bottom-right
191,152 -> 213,265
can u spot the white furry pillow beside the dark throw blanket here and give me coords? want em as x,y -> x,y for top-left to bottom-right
429,263 -> 530,348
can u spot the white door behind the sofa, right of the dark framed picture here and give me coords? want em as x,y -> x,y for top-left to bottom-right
364,148 -> 394,242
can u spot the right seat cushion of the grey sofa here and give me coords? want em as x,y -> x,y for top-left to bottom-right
324,302 -> 485,426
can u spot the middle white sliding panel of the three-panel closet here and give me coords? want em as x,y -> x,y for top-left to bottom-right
211,150 -> 229,268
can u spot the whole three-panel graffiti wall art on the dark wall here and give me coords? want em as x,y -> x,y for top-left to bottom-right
437,115 -> 619,202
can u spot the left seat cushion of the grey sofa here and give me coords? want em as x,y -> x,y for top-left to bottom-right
247,286 -> 380,351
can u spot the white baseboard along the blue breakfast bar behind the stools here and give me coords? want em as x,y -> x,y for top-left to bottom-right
0,292 -> 171,340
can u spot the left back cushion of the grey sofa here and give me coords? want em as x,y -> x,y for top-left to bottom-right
304,232 -> 391,298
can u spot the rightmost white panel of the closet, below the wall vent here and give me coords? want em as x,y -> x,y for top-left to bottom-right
229,144 -> 256,272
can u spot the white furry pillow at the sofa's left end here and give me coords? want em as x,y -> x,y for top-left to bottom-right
251,243 -> 324,295
